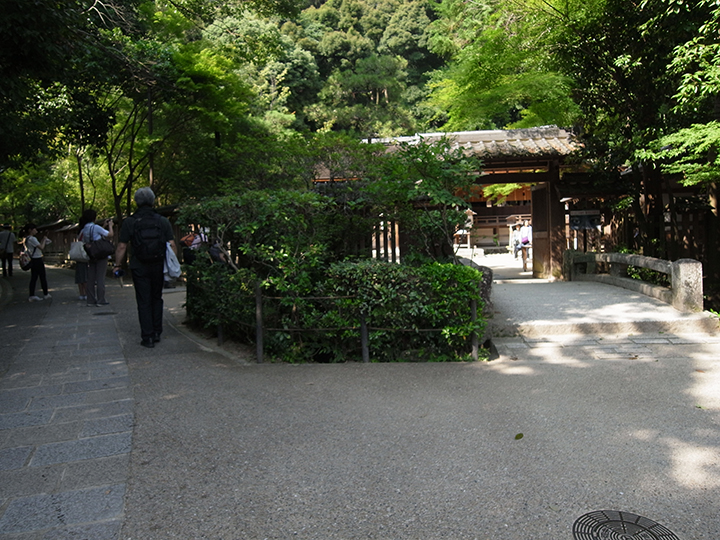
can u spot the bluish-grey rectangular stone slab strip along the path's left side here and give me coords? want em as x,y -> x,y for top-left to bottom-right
0,271 -> 133,540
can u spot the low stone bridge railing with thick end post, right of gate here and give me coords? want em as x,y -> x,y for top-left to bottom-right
563,250 -> 703,312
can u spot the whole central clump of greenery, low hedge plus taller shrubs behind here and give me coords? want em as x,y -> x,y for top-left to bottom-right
179,135 -> 483,361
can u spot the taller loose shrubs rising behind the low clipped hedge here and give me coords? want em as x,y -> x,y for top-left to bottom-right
179,139 -> 477,268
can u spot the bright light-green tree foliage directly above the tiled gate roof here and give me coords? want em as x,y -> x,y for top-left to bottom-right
424,0 -> 578,131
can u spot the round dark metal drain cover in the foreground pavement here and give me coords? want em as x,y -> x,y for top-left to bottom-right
573,510 -> 680,540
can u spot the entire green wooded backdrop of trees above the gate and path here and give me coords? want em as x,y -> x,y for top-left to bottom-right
0,0 -> 720,260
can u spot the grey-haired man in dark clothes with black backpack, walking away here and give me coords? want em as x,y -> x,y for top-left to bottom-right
113,187 -> 177,348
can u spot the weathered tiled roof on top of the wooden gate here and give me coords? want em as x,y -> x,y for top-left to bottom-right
377,126 -> 580,159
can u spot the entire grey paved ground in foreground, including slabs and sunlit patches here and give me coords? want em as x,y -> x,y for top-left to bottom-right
0,260 -> 720,540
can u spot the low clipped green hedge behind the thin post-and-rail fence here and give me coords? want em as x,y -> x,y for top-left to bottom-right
186,256 -> 485,362
